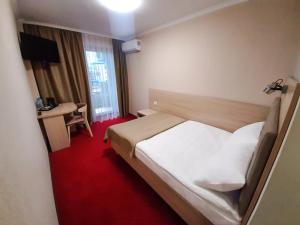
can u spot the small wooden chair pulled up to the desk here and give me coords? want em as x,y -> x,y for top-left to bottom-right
66,103 -> 93,142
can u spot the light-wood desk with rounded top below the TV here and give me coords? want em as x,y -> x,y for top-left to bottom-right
38,102 -> 77,151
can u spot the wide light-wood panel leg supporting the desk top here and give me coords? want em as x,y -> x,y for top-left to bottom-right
43,116 -> 70,152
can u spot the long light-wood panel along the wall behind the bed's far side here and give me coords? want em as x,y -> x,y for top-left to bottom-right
149,89 -> 269,132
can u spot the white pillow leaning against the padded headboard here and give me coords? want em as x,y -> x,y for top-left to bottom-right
194,122 -> 264,192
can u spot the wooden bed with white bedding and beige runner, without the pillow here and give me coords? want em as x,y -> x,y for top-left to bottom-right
107,78 -> 300,225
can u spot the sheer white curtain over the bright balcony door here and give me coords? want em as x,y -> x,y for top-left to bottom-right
82,34 -> 119,121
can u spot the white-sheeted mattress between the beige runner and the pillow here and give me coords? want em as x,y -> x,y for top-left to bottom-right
135,121 -> 241,225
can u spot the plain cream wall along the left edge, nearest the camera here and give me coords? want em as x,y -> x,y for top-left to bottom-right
0,0 -> 58,225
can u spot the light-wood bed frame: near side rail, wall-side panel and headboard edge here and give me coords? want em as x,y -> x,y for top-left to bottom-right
111,78 -> 300,225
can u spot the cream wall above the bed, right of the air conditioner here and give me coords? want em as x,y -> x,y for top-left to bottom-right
127,0 -> 300,113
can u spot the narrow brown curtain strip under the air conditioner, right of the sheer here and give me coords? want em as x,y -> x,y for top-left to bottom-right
112,39 -> 129,116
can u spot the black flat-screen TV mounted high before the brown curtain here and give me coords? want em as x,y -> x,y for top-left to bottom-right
20,33 -> 59,63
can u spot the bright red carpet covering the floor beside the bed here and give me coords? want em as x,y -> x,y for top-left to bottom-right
49,117 -> 184,225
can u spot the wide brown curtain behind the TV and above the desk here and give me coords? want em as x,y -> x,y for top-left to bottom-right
24,24 -> 90,119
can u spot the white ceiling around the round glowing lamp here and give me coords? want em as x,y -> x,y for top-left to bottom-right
18,0 -> 243,39
